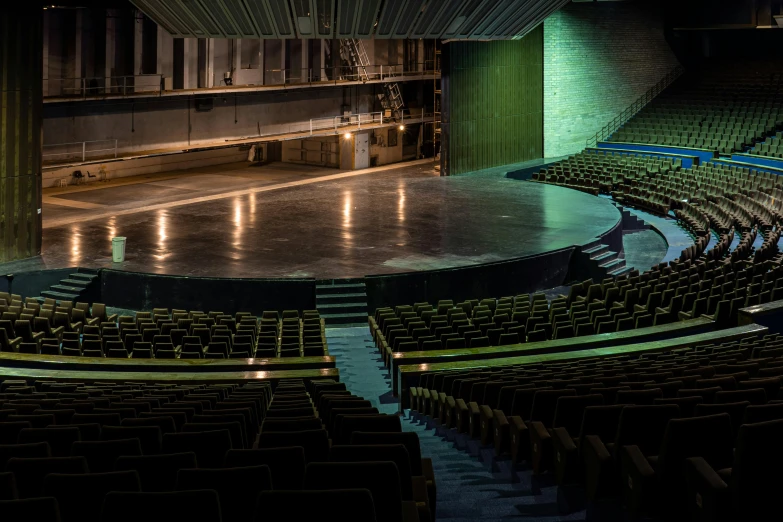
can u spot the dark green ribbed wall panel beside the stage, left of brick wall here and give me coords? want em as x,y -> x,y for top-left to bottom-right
441,27 -> 544,175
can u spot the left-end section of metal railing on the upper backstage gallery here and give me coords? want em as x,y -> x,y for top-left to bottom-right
43,74 -> 164,98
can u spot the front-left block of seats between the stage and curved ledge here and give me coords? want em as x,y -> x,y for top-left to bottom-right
0,298 -> 328,359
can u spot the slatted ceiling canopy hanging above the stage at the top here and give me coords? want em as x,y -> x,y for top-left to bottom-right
131,0 -> 570,40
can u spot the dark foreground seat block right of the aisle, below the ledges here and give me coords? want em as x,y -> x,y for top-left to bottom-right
409,334 -> 783,521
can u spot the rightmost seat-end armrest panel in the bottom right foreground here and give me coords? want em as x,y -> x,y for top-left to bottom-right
685,457 -> 731,522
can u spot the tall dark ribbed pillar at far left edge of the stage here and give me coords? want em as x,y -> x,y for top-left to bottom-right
0,7 -> 44,262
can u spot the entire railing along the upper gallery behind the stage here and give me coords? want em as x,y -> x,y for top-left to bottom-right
43,60 -> 440,99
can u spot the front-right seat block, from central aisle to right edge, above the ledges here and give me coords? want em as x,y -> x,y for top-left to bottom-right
368,253 -> 783,365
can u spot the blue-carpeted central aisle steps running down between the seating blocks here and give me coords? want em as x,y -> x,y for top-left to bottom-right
326,325 -> 585,522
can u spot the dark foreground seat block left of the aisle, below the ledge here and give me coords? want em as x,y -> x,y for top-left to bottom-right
0,380 -> 436,522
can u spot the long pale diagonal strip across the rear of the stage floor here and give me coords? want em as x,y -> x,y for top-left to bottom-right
43,158 -> 433,228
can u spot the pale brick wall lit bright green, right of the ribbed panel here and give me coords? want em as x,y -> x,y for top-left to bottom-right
544,1 -> 678,158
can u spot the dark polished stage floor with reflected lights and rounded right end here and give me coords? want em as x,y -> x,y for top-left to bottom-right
42,161 -> 620,279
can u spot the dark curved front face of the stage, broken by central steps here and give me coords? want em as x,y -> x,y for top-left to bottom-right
0,213 -> 623,314
